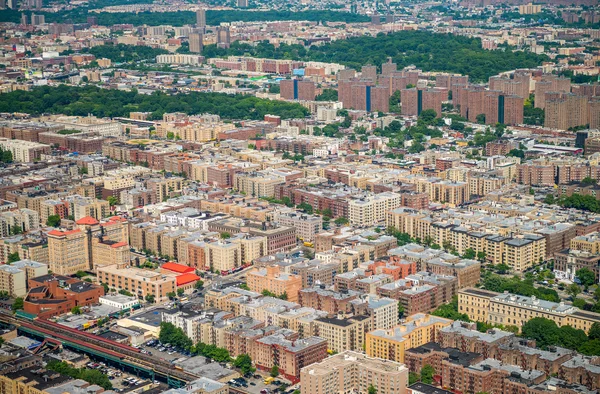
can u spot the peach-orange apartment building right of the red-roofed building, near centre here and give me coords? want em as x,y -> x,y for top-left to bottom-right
246,265 -> 302,302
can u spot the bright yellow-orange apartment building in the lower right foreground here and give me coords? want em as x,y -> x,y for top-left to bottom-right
366,313 -> 453,363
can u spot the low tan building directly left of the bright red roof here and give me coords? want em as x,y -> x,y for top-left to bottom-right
97,264 -> 177,302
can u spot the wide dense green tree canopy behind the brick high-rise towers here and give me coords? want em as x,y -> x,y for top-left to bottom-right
203,30 -> 548,81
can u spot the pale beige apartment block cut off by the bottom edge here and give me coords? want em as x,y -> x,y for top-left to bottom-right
300,351 -> 408,394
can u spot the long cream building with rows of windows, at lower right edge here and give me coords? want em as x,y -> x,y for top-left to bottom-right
458,288 -> 600,332
